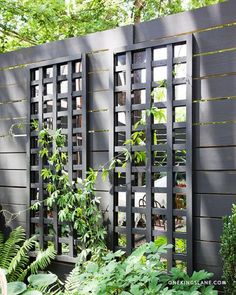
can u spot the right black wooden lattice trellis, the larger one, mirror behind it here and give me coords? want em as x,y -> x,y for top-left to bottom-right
111,37 -> 192,272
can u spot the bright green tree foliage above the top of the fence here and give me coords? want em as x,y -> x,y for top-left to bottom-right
0,0 -> 224,52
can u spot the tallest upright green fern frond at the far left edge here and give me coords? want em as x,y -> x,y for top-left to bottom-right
0,226 -> 25,269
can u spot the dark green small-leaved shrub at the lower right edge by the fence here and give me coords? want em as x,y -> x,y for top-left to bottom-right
220,205 -> 236,294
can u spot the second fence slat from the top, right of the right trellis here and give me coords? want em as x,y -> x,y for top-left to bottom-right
194,22 -> 236,54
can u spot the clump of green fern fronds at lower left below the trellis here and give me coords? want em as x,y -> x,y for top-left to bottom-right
0,227 -> 55,282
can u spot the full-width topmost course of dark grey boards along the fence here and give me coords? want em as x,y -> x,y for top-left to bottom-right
0,0 -> 233,70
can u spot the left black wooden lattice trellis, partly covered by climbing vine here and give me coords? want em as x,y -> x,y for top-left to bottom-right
29,55 -> 87,261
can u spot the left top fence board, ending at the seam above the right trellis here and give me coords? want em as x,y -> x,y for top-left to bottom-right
0,26 -> 133,68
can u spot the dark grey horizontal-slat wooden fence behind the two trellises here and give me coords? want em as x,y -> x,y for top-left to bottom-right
0,0 -> 236,278
